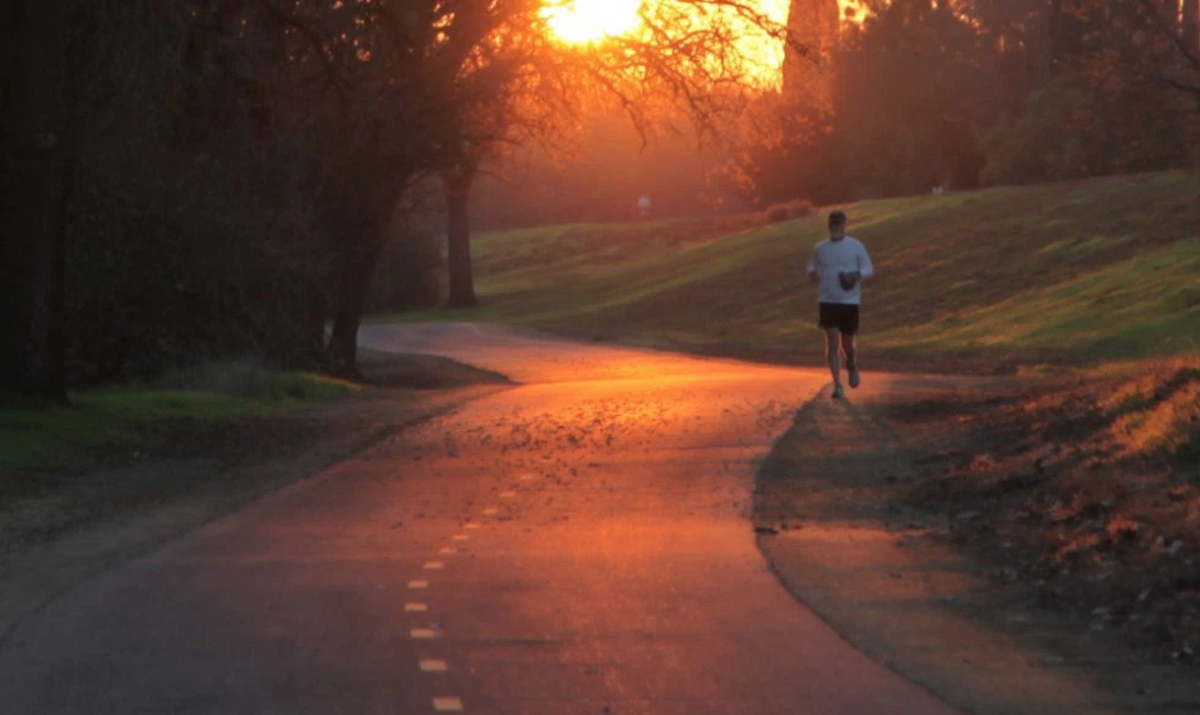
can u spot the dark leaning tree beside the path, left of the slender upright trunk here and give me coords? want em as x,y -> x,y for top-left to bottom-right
211,0 -> 511,373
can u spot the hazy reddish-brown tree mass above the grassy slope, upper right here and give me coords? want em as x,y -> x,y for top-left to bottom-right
742,0 -> 1200,203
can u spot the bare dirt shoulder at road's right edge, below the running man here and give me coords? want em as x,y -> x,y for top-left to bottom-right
756,375 -> 1200,715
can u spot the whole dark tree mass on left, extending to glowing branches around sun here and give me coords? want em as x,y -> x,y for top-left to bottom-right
0,0 -> 811,397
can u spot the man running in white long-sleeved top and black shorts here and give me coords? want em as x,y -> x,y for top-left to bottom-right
809,211 -> 875,399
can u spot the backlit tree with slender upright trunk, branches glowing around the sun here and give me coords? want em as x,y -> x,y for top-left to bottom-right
442,0 -> 808,307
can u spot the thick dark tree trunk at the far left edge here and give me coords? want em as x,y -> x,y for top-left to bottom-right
0,0 -> 74,402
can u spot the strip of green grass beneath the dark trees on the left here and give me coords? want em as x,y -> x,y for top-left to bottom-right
0,362 -> 356,475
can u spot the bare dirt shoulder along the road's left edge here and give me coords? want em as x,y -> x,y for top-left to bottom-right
0,352 -> 511,641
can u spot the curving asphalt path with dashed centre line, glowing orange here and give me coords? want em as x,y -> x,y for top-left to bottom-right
0,325 -> 954,715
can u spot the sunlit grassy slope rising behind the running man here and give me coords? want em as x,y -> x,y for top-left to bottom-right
374,172 -> 1200,365
